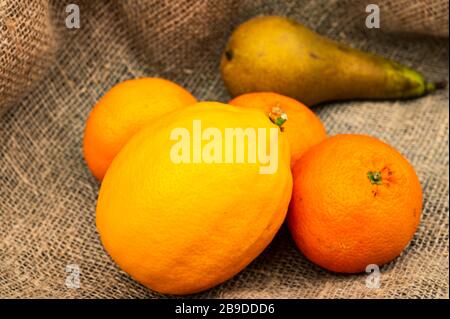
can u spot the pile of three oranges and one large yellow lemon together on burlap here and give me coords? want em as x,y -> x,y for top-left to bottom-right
83,78 -> 422,294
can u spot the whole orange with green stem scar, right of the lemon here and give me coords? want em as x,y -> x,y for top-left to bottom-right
288,134 -> 422,273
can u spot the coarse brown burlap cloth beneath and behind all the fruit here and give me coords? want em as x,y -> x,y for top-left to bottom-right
0,0 -> 449,298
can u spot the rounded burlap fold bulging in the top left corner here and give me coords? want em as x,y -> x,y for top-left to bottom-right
0,0 -> 57,115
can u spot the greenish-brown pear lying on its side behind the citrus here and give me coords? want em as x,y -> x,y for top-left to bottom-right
220,16 -> 436,105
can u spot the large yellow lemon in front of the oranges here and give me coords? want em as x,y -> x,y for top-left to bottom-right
96,102 -> 292,294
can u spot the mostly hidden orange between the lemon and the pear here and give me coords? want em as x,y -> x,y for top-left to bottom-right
229,92 -> 326,165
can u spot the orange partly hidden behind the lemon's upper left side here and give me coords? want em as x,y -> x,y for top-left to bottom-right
83,78 -> 196,180
